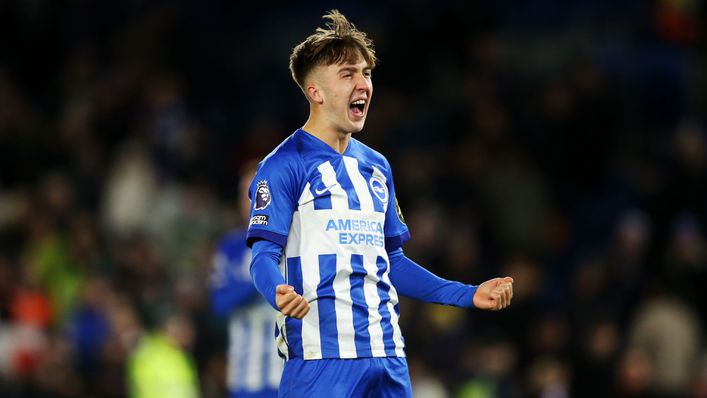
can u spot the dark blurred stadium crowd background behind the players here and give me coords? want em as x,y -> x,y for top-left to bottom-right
0,0 -> 707,398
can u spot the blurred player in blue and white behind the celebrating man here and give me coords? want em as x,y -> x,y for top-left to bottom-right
211,163 -> 283,398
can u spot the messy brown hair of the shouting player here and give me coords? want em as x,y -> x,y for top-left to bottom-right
290,10 -> 376,91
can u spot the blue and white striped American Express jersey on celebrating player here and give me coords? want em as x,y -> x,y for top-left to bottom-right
248,129 -> 410,360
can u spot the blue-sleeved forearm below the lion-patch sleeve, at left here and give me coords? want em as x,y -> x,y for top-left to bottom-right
250,239 -> 286,311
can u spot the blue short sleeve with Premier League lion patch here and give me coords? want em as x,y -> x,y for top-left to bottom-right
247,158 -> 299,247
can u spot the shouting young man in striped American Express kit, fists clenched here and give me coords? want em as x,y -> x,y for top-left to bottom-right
248,10 -> 513,397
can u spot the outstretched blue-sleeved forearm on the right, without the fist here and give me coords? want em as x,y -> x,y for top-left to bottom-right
388,248 -> 476,307
